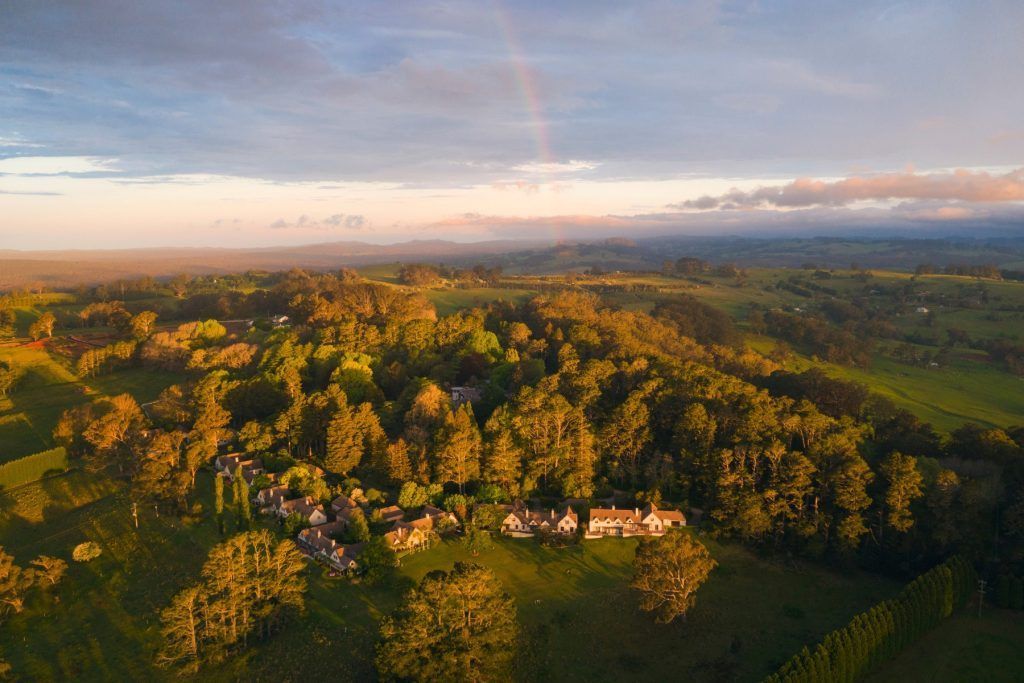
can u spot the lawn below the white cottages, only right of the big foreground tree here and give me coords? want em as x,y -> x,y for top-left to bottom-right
391,539 -> 897,681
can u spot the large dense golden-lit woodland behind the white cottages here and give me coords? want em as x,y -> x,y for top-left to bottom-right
36,270 -> 1024,581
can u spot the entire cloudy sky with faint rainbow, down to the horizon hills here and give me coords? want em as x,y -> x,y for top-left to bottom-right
0,0 -> 1024,249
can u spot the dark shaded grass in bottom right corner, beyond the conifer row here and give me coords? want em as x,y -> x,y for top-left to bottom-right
868,608 -> 1024,683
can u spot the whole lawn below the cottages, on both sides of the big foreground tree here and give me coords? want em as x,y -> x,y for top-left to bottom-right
218,539 -> 899,681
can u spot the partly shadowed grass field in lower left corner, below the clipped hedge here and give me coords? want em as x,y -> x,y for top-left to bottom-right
0,471 -> 217,681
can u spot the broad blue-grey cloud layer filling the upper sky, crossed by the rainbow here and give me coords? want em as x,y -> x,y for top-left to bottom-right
9,0 -> 1024,186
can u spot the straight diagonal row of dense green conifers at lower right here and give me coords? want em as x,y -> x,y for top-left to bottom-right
765,556 -> 977,683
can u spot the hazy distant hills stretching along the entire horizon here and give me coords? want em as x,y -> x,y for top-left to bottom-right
0,237 -> 1024,291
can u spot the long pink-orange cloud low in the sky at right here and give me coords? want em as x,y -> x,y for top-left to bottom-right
670,168 -> 1024,211
